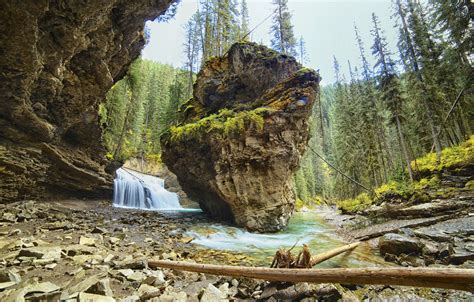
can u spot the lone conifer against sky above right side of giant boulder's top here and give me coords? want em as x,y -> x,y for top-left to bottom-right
271,0 -> 296,56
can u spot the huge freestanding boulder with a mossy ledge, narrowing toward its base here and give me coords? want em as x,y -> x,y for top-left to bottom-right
161,43 -> 319,231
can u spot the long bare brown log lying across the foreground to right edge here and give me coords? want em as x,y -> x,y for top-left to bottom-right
148,260 -> 474,292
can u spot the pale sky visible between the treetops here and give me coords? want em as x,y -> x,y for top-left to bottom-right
142,0 -> 397,85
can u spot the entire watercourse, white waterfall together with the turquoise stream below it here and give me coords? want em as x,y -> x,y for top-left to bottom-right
113,169 -> 387,267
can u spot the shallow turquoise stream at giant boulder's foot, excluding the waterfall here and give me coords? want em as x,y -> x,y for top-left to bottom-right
185,212 -> 387,268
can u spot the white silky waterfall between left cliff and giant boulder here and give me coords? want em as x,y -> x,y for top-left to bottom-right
114,168 -> 182,210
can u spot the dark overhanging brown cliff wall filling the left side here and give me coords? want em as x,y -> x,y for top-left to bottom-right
0,0 -> 177,202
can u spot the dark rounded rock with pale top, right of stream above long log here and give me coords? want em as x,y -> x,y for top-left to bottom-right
379,233 -> 422,256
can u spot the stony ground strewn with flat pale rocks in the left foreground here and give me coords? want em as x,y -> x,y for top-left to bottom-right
0,200 -> 472,302
